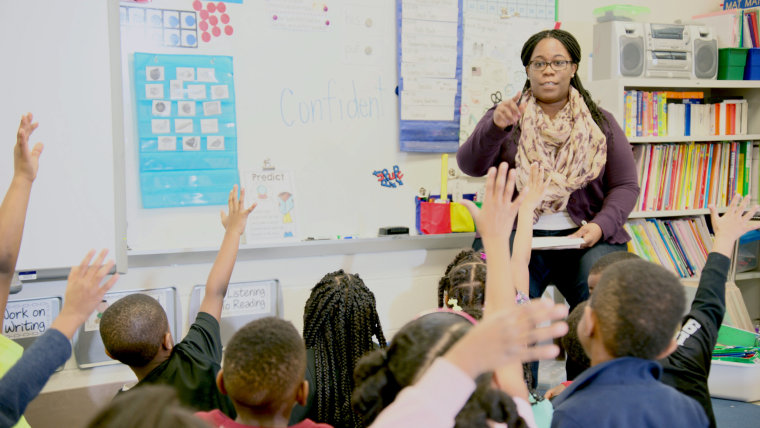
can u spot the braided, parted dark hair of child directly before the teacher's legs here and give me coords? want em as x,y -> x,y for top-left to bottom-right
438,250 -> 486,319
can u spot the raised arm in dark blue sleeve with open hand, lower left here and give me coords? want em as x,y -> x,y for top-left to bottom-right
0,250 -> 119,427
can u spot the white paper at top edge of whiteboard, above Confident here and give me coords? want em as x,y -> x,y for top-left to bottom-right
266,0 -> 332,31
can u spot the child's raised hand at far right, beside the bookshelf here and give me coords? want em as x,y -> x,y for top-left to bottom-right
710,195 -> 760,258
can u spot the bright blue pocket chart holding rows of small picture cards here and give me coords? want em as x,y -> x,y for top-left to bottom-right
133,53 -> 239,208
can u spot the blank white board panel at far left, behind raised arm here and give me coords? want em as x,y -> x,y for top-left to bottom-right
0,0 -> 126,271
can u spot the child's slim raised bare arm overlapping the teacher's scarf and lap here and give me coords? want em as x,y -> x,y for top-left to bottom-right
512,162 -> 546,296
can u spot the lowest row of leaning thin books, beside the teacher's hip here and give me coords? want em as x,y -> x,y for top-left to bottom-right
623,216 -> 712,278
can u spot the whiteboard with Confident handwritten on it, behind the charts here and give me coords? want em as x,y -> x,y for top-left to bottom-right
122,0 -> 484,254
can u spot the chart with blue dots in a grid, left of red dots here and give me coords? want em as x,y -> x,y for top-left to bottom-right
119,6 -> 198,48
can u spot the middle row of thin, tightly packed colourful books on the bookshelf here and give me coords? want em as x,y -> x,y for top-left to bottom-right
633,141 -> 760,211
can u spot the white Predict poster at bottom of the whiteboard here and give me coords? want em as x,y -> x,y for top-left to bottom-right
240,170 -> 299,244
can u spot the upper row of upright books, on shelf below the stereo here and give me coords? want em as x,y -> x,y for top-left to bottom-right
623,90 -> 748,137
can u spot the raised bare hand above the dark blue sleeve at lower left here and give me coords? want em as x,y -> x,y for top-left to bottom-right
51,250 -> 119,339
